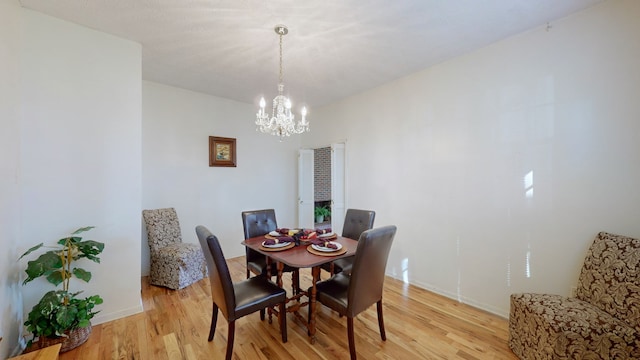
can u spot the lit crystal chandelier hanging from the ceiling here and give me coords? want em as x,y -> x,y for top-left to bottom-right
256,25 -> 309,141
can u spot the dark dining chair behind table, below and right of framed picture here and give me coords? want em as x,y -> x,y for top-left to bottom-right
242,209 -> 300,296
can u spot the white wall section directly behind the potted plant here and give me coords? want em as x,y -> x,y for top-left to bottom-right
19,9 -> 142,336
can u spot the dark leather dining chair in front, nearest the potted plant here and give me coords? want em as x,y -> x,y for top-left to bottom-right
196,225 -> 287,360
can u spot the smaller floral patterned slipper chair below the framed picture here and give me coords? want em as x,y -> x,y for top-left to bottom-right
142,208 -> 208,289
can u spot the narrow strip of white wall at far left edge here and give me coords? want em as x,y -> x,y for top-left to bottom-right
0,0 -> 23,359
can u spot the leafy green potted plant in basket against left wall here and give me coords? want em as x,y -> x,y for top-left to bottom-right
20,226 -> 104,352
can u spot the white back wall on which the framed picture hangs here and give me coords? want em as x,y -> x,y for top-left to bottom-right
142,81 -> 300,275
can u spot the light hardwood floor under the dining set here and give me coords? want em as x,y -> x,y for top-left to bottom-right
60,257 -> 517,360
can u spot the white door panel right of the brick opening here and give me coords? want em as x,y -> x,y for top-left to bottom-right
331,144 -> 345,234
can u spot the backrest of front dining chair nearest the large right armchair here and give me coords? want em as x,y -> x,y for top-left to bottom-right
346,225 -> 397,317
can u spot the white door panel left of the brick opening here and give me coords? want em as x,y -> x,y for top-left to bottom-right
298,149 -> 314,229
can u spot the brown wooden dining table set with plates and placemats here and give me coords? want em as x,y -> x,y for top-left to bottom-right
242,234 -> 358,344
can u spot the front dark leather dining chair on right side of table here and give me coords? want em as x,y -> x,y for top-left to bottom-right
309,225 -> 396,359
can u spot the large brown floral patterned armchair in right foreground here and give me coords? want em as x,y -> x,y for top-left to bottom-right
509,232 -> 640,360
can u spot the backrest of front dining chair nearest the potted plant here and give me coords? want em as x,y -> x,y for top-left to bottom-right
196,225 -> 236,321
